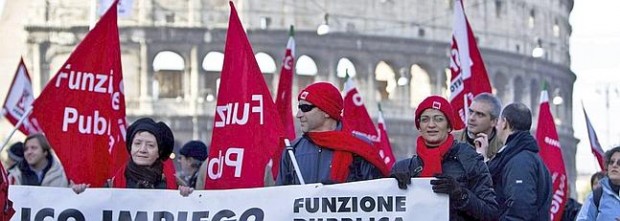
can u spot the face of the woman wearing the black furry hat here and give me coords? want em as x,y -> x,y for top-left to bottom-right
131,131 -> 159,166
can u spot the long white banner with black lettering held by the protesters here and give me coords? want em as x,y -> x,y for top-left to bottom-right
9,178 -> 449,221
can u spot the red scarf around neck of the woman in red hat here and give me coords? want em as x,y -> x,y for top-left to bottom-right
417,134 -> 454,177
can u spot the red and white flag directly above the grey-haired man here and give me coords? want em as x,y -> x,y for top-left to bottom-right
450,0 -> 491,130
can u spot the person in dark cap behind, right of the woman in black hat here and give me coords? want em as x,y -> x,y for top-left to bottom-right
178,140 -> 209,189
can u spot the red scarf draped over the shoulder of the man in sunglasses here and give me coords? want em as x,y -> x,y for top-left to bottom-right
306,131 -> 390,183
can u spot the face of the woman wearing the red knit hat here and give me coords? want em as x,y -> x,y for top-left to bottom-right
418,108 -> 450,147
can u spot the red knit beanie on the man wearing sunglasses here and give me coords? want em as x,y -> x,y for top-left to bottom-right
297,82 -> 343,121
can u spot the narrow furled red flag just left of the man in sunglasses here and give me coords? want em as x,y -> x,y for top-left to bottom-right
271,25 -> 295,180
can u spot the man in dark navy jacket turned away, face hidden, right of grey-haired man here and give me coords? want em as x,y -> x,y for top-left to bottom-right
487,103 -> 552,220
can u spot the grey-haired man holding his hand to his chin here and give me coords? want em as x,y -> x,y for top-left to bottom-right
454,93 -> 504,161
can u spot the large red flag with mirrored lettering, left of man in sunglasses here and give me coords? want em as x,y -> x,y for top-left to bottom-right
205,1 -> 284,189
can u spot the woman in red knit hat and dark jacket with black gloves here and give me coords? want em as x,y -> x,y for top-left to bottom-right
391,96 -> 498,220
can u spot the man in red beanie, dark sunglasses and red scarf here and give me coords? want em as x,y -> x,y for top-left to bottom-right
276,82 -> 389,185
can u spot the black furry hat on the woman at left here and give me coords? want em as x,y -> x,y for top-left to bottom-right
125,118 -> 174,160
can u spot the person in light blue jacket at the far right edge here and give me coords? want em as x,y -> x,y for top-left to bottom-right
577,146 -> 620,221
